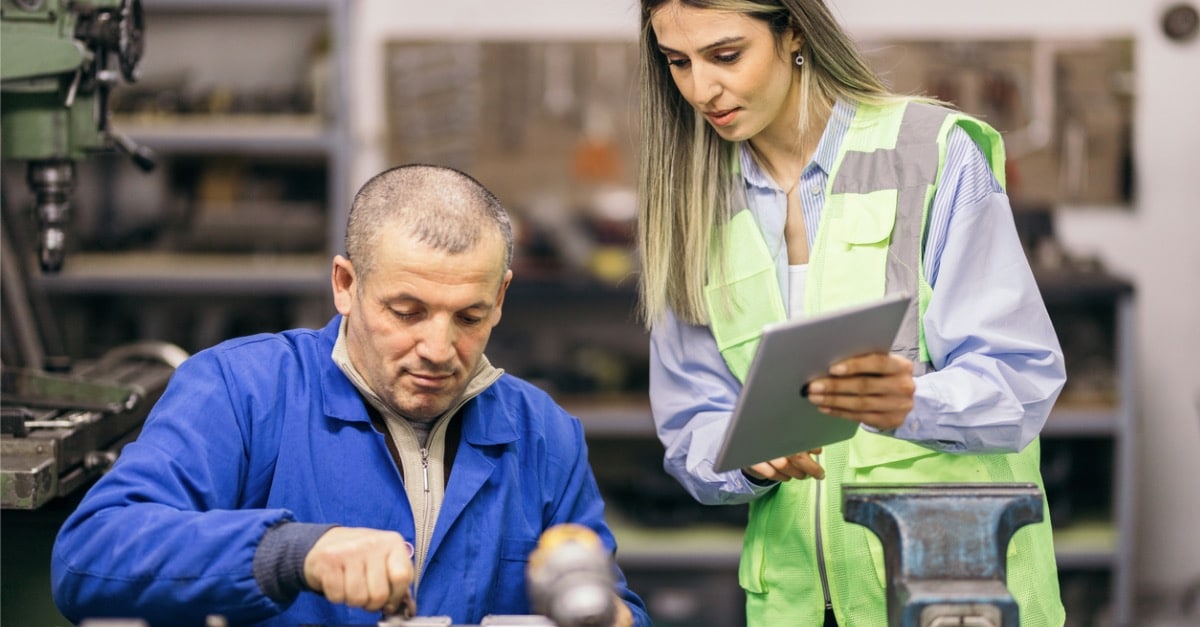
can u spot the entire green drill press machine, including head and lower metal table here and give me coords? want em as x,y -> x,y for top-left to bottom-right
0,0 -> 187,509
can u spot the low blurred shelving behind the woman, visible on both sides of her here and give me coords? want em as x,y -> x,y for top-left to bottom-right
513,271 -> 1136,627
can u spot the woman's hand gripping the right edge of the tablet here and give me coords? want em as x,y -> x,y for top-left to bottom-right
808,353 -> 917,431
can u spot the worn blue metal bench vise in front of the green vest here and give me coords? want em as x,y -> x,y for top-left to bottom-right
842,483 -> 1043,627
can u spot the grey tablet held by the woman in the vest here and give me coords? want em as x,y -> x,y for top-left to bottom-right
714,294 -> 911,472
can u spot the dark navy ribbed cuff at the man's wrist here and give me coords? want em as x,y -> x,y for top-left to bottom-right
254,523 -> 337,604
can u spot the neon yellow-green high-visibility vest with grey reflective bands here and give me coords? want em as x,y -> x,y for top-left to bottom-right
706,102 -> 1066,627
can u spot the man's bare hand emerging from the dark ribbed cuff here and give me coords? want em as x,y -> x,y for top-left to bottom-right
304,527 -> 415,614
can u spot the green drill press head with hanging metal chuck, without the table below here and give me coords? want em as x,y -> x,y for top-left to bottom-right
0,0 -> 154,273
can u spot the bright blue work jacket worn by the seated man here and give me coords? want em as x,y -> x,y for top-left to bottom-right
52,316 -> 649,626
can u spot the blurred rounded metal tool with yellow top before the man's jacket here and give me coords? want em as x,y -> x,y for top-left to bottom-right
526,524 -> 617,627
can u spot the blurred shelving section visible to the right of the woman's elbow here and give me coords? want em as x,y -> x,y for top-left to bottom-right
1038,271 -> 1138,627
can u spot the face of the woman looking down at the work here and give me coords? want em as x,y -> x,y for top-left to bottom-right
650,2 -> 800,142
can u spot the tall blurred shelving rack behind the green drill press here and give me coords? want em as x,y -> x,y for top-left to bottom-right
27,0 -> 350,354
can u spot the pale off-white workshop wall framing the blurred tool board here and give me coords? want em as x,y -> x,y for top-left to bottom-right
349,0 -> 1200,614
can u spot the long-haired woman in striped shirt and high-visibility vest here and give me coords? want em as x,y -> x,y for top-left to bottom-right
638,0 -> 1066,627
